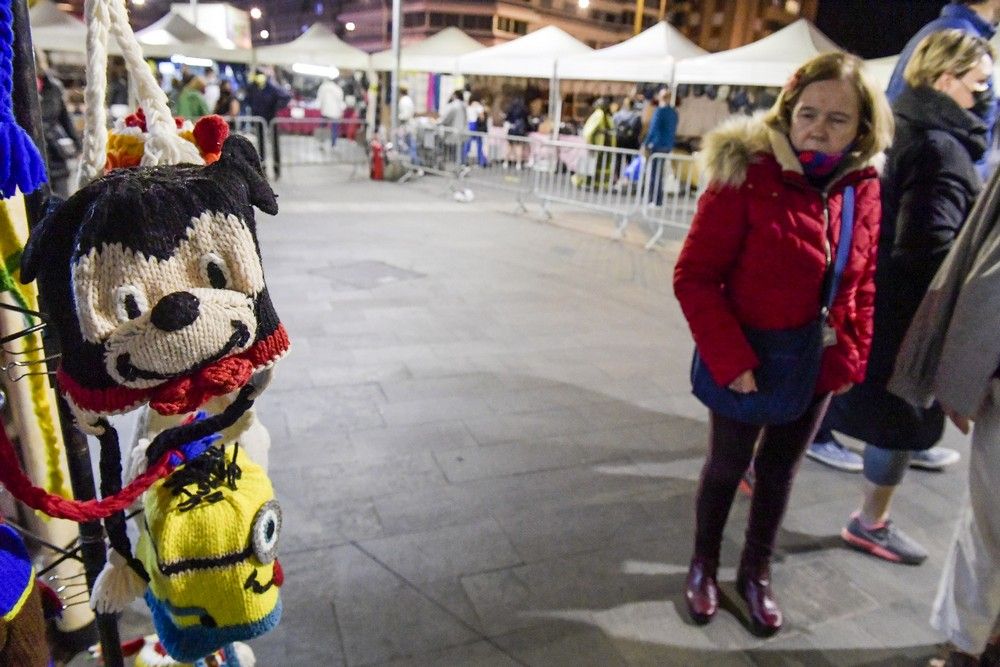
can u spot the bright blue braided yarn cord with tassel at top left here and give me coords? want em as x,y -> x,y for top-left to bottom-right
0,0 -> 46,199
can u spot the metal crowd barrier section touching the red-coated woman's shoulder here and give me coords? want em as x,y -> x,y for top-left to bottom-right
641,153 -> 705,250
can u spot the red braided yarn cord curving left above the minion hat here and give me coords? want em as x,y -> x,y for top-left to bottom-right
0,422 -> 174,523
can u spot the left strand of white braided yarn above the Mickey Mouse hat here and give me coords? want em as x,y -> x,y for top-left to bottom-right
78,0 -> 111,187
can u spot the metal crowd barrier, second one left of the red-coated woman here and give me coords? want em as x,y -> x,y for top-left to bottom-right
531,141 -> 642,237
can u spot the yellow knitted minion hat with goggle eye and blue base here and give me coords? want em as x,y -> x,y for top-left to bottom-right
136,444 -> 284,661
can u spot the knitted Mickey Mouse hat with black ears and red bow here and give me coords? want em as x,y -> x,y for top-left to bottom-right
21,136 -> 289,429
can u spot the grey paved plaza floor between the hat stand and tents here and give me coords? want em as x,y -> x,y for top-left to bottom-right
172,168 -> 968,666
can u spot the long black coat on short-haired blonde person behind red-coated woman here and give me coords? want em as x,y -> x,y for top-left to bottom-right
826,82 -> 986,450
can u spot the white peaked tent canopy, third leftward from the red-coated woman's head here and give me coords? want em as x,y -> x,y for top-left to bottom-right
458,25 -> 593,79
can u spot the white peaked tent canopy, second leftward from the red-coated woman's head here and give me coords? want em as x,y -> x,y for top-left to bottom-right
556,21 -> 708,83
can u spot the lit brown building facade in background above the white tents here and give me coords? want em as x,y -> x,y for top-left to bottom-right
62,0 -> 819,51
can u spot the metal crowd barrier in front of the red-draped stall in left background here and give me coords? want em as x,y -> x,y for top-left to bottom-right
267,117 -> 368,178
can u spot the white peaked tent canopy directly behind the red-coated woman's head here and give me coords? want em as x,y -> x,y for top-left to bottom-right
675,19 -> 841,86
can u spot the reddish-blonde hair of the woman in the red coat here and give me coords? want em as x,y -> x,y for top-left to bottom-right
764,51 -> 895,161
